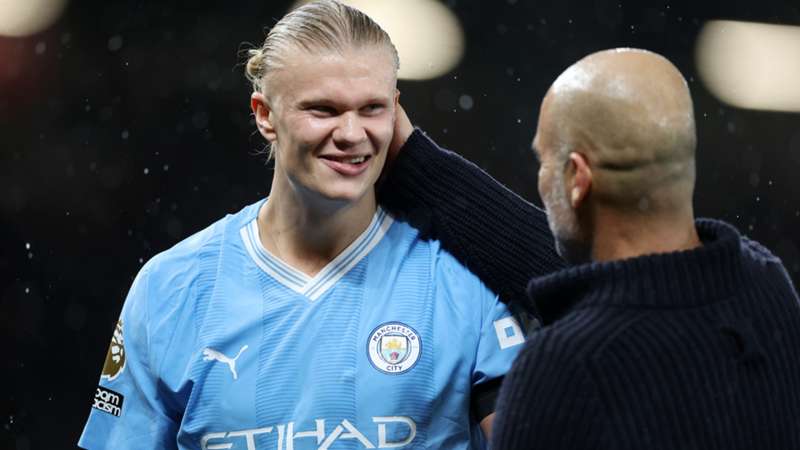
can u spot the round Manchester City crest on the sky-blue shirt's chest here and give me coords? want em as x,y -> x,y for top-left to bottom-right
367,322 -> 422,374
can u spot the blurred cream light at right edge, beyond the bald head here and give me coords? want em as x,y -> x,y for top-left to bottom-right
695,20 -> 800,112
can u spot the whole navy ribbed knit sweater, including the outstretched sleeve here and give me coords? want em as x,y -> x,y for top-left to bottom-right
381,131 -> 800,450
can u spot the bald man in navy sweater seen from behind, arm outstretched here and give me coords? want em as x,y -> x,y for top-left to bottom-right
384,49 -> 800,450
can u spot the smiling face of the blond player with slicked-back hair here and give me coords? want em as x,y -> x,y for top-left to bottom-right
254,46 -> 397,207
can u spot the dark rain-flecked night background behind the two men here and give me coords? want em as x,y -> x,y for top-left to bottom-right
0,0 -> 800,449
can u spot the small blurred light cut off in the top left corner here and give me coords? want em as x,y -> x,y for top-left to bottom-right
0,0 -> 67,37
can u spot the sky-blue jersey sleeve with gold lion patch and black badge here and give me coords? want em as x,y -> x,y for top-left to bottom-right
78,266 -> 177,450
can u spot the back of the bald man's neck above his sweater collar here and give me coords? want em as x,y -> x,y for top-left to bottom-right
592,210 -> 702,261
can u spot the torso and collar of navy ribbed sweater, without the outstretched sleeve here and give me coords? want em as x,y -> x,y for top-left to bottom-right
492,220 -> 800,450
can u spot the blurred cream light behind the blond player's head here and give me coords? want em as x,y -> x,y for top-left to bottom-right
292,0 -> 464,80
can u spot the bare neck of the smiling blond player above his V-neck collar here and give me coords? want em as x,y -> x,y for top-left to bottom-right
258,173 -> 377,276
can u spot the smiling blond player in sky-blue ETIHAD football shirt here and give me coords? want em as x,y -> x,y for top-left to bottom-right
80,1 -> 523,450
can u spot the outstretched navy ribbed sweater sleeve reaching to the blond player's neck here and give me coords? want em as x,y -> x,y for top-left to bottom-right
379,129 -> 564,305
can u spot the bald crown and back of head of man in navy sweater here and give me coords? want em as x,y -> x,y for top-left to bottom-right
536,49 -> 696,211
